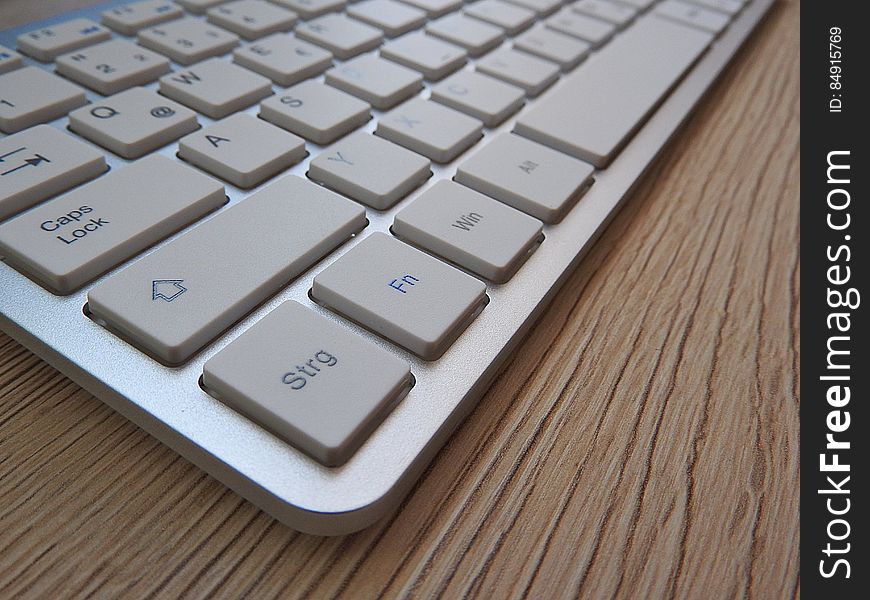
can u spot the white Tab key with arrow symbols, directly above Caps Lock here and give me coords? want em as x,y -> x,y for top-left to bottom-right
0,125 -> 107,220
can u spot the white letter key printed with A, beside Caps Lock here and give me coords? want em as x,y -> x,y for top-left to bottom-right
178,113 -> 305,188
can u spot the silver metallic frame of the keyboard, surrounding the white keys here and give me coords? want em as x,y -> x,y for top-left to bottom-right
0,0 -> 774,535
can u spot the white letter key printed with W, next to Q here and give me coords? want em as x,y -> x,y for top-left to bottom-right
160,58 -> 272,119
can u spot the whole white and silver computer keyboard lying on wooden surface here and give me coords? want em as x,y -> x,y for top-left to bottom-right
0,0 -> 772,534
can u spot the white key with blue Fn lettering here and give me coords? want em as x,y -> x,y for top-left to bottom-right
311,232 -> 486,360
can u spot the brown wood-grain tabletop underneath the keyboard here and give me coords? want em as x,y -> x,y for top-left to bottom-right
0,0 -> 800,599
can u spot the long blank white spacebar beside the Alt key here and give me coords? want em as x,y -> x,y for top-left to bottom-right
514,14 -> 713,168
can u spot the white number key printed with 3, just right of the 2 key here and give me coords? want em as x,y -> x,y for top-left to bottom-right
138,18 -> 239,65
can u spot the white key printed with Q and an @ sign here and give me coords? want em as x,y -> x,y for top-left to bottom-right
69,88 -> 199,158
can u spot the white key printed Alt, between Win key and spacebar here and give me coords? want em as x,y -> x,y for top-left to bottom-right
454,133 -> 593,223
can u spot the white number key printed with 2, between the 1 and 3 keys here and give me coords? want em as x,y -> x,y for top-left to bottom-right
57,40 -> 169,96
